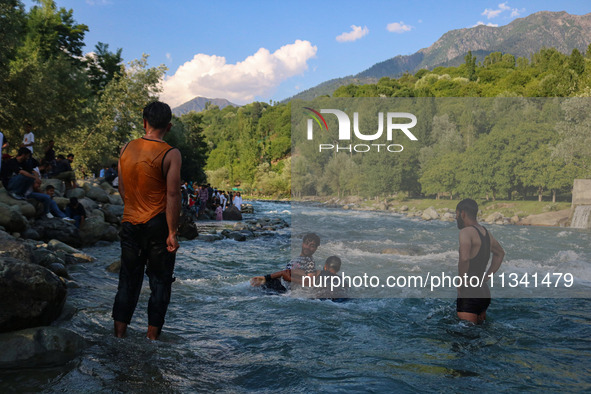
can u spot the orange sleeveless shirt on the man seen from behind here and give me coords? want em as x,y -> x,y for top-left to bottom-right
119,138 -> 173,224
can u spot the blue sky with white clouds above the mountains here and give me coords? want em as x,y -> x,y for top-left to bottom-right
25,0 -> 591,106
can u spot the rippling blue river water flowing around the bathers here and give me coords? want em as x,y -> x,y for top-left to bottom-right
0,202 -> 591,393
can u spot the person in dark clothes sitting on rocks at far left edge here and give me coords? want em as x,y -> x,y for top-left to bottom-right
2,147 -> 39,200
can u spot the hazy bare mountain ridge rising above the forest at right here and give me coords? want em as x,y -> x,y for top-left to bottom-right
286,11 -> 591,101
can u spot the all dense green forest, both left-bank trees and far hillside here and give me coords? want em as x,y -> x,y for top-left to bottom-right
0,0 -> 591,202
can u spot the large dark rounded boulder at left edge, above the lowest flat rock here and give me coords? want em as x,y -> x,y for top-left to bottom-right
0,257 -> 67,332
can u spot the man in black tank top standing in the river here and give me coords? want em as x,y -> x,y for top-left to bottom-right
456,198 -> 505,324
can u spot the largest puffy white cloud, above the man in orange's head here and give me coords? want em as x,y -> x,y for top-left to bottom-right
161,40 -> 317,107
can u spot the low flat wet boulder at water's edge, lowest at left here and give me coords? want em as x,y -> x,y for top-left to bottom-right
0,327 -> 85,369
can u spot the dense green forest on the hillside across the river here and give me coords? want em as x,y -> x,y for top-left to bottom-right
200,48 -> 591,200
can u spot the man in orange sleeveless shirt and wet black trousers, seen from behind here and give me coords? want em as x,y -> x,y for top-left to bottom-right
113,101 -> 181,340
